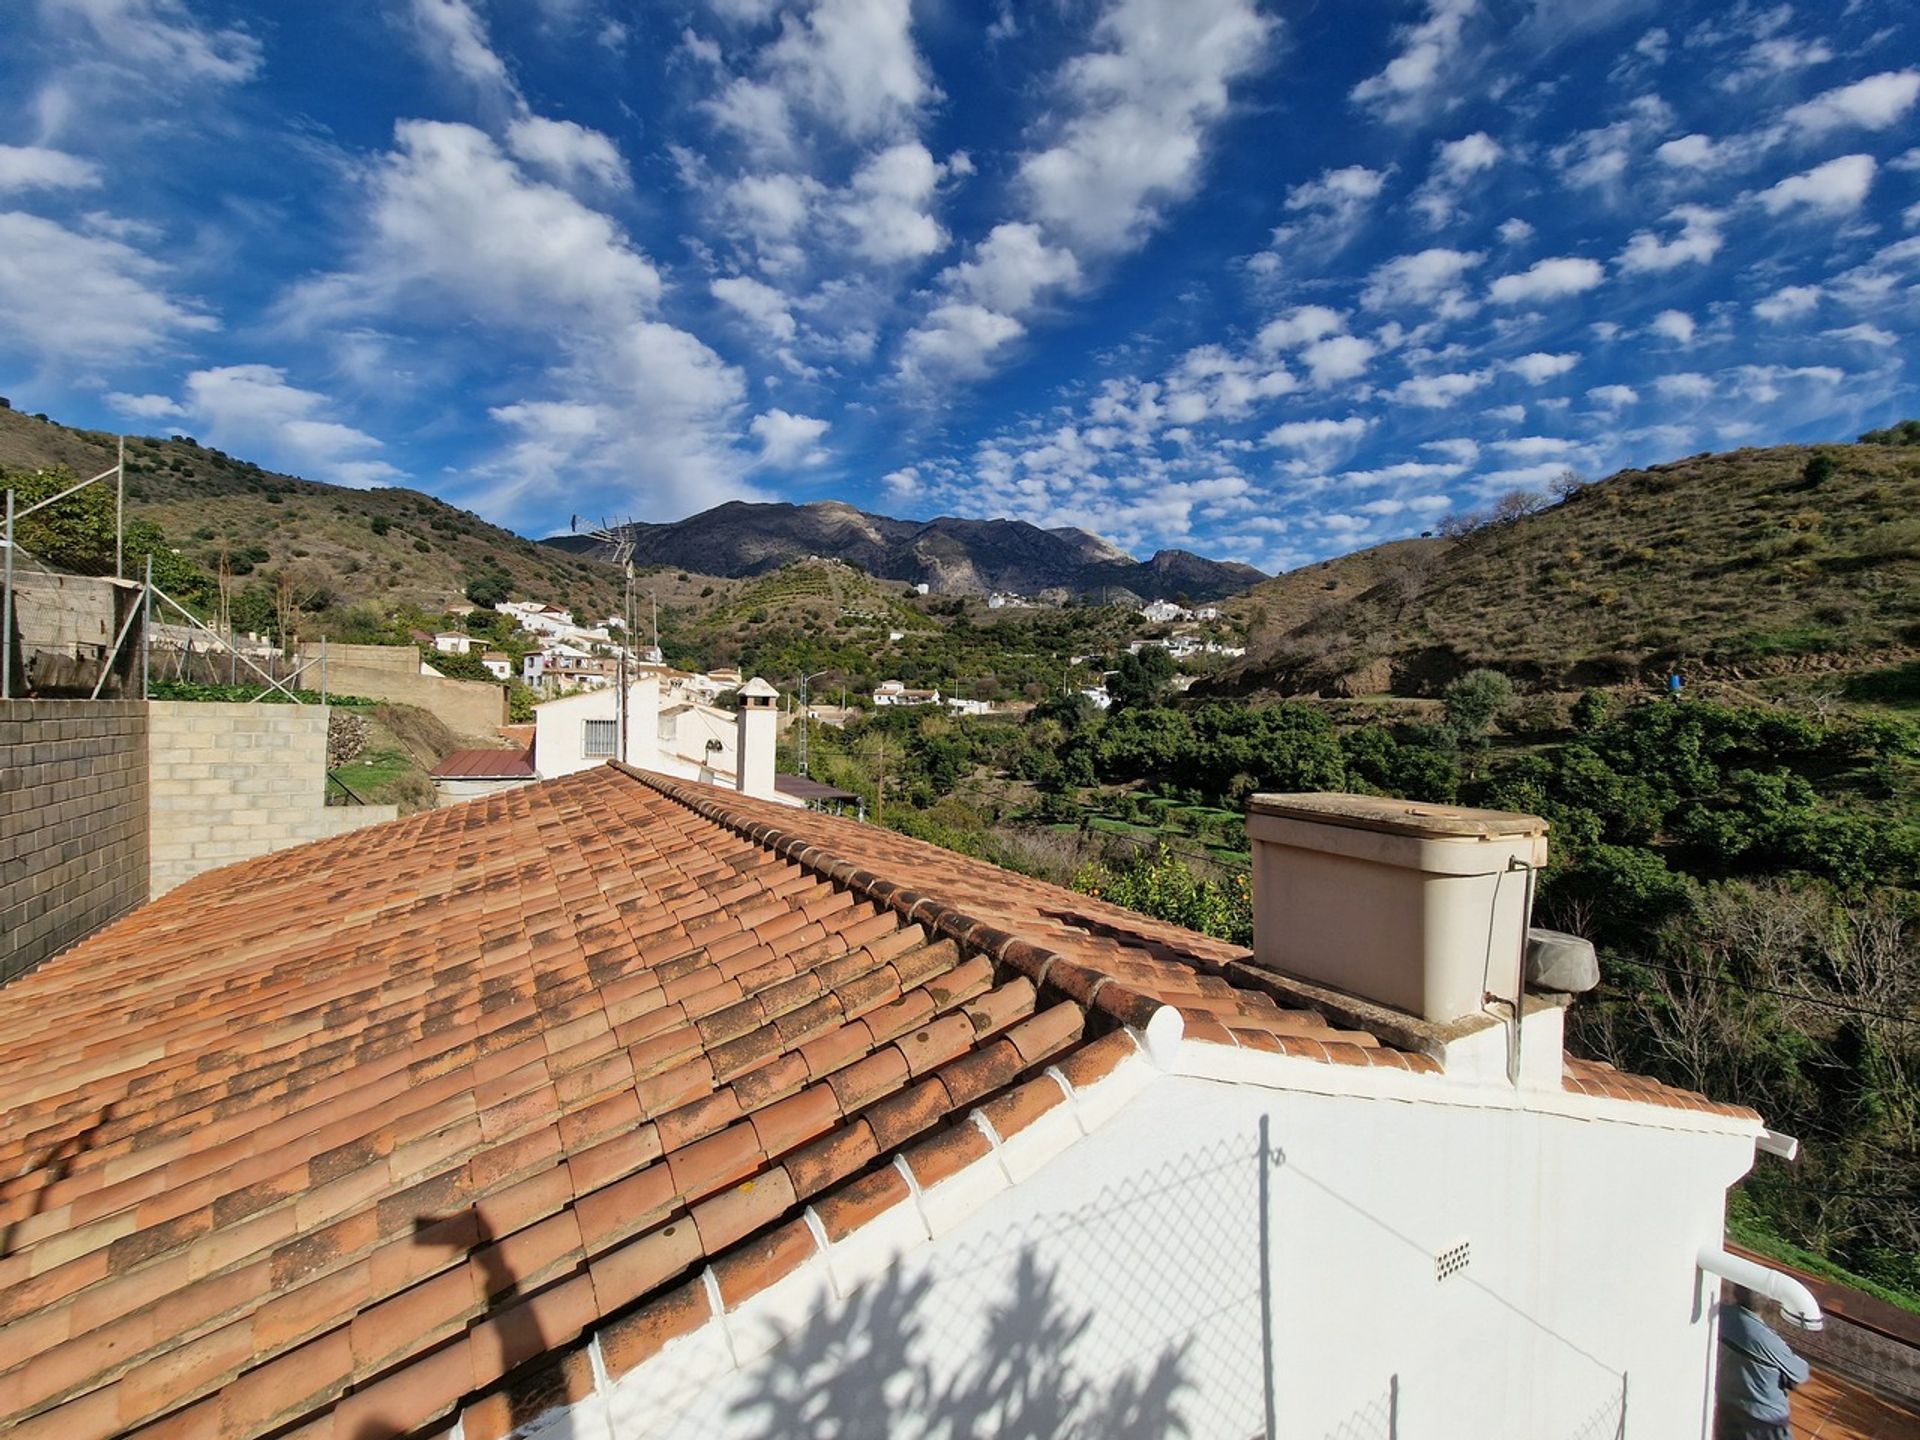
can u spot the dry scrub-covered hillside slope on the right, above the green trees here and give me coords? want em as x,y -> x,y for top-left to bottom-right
1221,444 -> 1920,695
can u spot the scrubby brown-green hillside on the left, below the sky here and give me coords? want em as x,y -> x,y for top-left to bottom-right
0,411 -> 618,636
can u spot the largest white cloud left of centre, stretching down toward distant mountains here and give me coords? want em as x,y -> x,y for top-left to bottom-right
286,121 -> 753,520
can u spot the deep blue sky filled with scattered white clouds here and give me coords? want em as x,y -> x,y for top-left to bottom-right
0,0 -> 1920,570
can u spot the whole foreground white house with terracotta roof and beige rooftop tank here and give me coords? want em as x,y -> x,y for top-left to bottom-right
0,760 -> 1818,1440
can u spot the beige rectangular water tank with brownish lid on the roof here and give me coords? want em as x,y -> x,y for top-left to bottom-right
1246,795 -> 1548,1021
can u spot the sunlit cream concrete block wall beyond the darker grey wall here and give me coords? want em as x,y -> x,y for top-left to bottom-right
148,701 -> 397,897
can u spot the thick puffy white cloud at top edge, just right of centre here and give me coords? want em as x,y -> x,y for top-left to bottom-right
1020,0 -> 1273,252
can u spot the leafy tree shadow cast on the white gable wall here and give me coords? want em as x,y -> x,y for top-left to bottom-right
733,1244 -> 1190,1440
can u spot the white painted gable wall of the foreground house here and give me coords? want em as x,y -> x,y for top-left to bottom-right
564,1067 -> 1753,1440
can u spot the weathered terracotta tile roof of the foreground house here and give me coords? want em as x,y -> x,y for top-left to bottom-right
0,766 -> 1758,1440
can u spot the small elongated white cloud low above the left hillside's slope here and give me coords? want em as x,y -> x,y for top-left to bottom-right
181,365 -> 401,486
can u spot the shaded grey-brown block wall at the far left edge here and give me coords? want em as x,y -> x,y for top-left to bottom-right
0,701 -> 148,981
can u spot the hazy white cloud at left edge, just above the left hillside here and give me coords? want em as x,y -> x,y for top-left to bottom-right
0,211 -> 219,369
